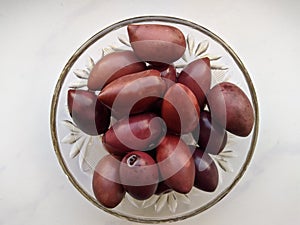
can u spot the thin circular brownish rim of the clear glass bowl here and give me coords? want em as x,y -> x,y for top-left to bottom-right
50,15 -> 259,224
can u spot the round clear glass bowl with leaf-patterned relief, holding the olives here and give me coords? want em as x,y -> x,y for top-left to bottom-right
50,16 -> 259,223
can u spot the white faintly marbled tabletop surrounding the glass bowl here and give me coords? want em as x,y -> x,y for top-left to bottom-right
0,0 -> 300,225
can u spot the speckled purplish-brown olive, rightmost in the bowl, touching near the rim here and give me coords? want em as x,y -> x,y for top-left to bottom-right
207,82 -> 254,137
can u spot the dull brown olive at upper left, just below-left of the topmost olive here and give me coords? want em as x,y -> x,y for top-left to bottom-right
88,51 -> 146,90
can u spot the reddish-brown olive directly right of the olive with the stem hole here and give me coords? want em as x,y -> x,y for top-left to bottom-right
156,135 -> 195,194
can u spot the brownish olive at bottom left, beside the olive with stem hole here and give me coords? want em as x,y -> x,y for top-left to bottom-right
92,155 -> 125,208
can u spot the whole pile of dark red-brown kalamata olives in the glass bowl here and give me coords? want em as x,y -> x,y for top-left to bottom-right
68,24 -> 254,208
